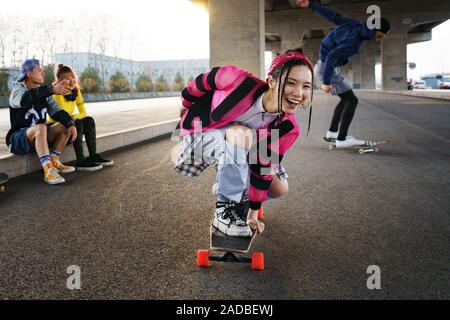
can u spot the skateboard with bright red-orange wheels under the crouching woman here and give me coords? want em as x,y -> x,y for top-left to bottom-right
197,209 -> 264,270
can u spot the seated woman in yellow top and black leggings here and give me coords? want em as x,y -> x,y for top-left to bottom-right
47,64 -> 114,171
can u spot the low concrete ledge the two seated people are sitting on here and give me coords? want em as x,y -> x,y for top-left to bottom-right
0,119 -> 179,177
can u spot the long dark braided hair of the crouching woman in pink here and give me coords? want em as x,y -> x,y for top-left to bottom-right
272,48 -> 314,135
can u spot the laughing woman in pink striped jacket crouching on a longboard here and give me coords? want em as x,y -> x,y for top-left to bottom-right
175,49 -> 313,237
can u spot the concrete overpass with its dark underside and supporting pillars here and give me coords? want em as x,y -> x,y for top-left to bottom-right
193,0 -> 450,90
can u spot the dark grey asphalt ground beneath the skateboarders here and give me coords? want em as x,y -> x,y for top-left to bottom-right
0,93 -> 450,299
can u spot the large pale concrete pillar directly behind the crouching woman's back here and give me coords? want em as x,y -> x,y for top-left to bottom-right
208,0 -> 265,77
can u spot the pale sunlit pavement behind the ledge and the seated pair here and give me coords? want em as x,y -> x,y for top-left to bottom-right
0,97 -> 181,155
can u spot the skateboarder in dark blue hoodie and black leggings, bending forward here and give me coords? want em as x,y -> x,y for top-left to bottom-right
297,0 -> 390,148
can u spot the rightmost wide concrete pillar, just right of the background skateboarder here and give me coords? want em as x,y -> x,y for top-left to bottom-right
381,33 -> 408,90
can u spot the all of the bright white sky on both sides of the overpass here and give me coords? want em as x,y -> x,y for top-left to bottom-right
1,0 -> 450,79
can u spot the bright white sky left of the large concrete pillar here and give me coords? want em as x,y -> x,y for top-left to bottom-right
0,0 -> 209,60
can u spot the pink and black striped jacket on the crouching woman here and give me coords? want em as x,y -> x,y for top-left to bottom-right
178,66 -> 300,210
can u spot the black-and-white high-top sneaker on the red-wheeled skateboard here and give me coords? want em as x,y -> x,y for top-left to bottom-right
213,202 -> 252,237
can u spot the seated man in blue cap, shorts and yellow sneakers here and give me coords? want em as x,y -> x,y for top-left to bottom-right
6,59 -> 77,184
